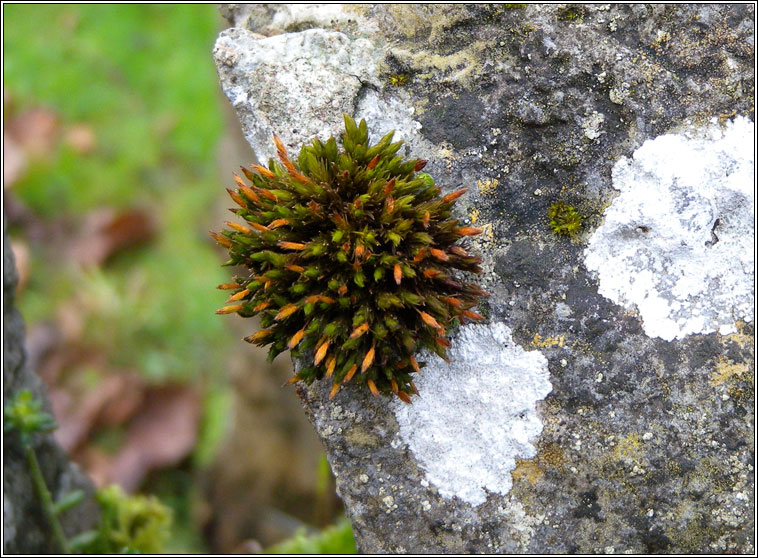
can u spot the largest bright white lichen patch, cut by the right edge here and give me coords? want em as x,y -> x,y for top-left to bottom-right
585,117 -> 755,341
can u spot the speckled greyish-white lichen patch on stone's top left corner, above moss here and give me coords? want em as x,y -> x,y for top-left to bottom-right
213,28 -> 383,161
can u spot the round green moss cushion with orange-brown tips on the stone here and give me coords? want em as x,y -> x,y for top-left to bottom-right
211,115 -> 486,402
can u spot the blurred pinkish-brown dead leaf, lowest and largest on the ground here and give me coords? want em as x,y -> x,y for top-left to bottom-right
109,385 -> 201,491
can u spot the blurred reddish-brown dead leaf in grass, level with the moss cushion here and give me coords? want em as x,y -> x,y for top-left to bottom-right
71,208 -> 156,267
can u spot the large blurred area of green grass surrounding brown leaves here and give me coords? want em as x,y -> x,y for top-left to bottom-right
3,4 -> 229,382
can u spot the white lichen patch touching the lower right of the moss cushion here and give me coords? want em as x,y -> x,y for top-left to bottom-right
394,323 -> 552,506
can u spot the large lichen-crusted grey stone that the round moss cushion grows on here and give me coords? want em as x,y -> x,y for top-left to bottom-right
214,4 -> 755,554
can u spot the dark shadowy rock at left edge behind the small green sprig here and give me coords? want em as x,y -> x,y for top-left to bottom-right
3,223 -> 100,554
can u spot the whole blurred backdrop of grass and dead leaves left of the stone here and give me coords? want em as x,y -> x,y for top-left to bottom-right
3,4 -> 354,553
